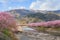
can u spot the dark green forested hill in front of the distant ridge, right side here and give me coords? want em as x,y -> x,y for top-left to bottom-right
27,13 -> 60,21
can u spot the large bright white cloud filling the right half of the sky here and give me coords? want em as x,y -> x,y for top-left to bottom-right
30,0 -> 60,10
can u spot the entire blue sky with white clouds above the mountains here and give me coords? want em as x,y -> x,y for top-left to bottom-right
0,0 -> 60,11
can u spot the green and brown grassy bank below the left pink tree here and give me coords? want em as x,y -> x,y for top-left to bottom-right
0,29 -> 17,40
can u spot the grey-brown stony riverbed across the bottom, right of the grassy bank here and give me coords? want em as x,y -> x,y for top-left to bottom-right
17,31 -> 60,40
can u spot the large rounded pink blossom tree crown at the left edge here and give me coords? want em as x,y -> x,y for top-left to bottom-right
0,12 -> 16,29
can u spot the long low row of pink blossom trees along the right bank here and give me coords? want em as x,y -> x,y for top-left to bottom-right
28,20 -> 60,27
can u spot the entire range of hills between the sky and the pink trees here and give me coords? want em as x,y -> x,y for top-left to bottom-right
7,9 -> 60,22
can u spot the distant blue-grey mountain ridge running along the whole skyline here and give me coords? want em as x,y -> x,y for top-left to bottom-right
7,9 -> 60,15
